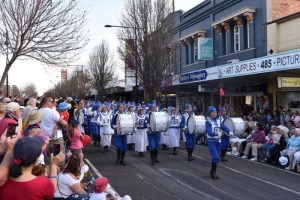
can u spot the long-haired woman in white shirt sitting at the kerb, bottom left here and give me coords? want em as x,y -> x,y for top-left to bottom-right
54,155 -> 85,199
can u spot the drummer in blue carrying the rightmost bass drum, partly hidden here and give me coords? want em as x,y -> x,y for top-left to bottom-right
219,106 -> 230,162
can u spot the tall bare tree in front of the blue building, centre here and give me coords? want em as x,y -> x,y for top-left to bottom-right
118,0 -> 175,100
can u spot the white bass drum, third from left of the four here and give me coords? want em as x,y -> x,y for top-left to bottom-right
187,115 -> 206,135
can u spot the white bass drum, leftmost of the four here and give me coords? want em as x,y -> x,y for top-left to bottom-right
116,114 -> 135,135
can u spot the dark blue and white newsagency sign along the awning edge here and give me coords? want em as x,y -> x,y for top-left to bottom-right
172,67 -> 218,85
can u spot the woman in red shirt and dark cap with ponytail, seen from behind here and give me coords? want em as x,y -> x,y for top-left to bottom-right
0,137 -> 54,200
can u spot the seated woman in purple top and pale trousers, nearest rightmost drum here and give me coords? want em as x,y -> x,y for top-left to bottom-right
242,123 -> 266,161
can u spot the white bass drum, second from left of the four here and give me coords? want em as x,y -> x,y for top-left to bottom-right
150,112 -> 169,132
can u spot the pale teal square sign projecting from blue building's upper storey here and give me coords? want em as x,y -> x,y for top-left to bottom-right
198,38 -> 214,60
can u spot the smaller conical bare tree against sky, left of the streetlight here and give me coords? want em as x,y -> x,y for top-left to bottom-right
87,40 -> 118,95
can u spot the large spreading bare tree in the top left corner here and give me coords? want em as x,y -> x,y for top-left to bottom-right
0,0 -> 88,86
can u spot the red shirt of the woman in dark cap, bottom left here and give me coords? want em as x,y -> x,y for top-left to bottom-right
0,176 -> 54,200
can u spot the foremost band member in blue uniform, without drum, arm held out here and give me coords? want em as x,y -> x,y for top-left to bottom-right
205,106 -> 232,179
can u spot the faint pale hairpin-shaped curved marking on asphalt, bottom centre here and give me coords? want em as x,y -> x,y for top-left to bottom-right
159,168 -> 237,199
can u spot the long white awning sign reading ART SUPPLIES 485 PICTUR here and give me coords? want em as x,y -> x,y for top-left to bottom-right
218,50 -> 300,79
